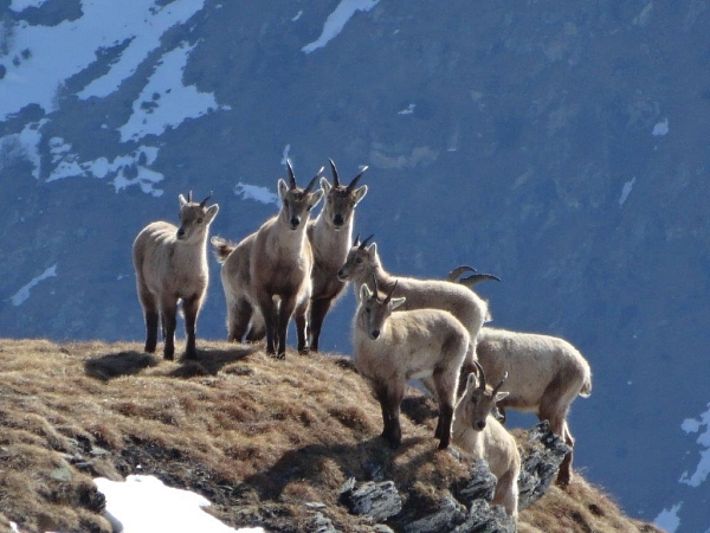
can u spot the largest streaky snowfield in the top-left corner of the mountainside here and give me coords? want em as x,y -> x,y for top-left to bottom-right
0,0 -> 204,121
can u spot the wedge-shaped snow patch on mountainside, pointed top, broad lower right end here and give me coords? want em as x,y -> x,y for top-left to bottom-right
119,42 -> 218,142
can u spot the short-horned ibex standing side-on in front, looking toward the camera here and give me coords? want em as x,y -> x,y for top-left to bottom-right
353,282 -> 470,449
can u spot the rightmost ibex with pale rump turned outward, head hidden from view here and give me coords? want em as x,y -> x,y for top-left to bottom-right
476,327 -> 592,485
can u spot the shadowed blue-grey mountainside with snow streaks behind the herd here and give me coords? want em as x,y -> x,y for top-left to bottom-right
0,0 -> 710,532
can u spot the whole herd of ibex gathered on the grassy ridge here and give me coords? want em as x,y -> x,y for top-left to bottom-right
133,160 -> 592,516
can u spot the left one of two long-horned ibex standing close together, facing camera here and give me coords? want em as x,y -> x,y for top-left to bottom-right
212,161 -> 323,358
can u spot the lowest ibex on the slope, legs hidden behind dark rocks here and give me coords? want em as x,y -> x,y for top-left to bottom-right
452,362 -> 520,519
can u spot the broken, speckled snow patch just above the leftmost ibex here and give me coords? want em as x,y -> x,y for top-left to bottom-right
47,141 -> 164,197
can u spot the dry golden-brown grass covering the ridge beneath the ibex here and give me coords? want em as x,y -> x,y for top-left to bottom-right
0,340 -> 654,532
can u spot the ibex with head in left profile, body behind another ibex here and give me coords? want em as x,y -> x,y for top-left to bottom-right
338,235 -> 490,394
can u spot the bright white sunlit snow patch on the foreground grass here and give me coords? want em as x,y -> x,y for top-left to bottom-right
94,475 -> 264,533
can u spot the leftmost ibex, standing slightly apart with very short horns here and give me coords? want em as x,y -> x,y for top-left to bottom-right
133,193 -> 219,359
